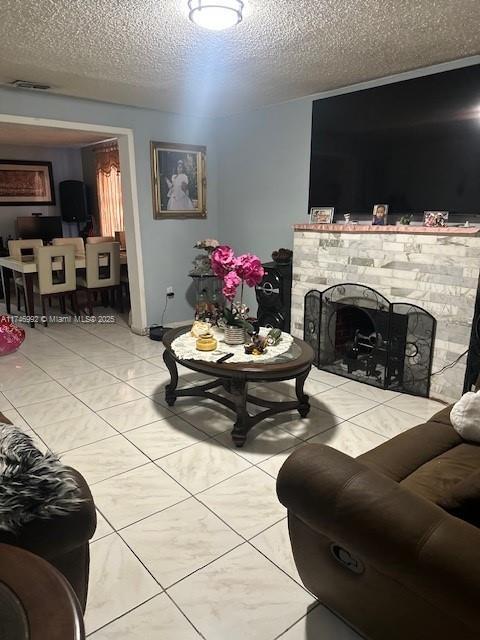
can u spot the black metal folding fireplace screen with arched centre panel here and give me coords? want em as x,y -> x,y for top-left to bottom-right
304,283 -> 436,397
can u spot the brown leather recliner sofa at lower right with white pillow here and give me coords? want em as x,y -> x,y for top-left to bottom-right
277,408 -> 480,640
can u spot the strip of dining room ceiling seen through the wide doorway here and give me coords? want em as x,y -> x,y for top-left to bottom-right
0,123 -> 110,147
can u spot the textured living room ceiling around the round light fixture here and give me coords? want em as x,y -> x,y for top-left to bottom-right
0,0 -> 480,115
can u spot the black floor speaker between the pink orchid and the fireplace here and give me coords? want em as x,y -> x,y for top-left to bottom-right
255,262 -> 292,333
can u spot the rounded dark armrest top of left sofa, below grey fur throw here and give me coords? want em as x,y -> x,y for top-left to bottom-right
0,468 -> 97,559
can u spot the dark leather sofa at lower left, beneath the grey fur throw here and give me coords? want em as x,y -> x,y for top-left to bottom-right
0,413 -> 97,611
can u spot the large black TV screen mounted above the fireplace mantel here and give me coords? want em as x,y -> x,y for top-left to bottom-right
309,65 -> 480,215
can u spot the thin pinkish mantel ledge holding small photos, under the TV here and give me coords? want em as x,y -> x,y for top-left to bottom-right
293,224 -> 480,236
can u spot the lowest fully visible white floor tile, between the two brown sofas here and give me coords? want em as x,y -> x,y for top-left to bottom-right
121,498 -> 243,588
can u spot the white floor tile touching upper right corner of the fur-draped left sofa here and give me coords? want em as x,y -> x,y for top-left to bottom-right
62,436 -> 150,485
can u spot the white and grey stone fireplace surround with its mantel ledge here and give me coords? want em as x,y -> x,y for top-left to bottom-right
292,224 -> 480,401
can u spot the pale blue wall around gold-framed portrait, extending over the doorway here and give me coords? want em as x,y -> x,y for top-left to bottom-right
0,88 -> 218,324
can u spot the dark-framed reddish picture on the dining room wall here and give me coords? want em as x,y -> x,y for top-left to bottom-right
0,160 -> 55,207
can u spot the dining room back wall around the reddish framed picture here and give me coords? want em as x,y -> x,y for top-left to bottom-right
0,145 -> 83,242
